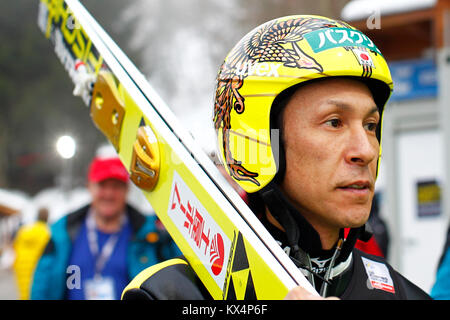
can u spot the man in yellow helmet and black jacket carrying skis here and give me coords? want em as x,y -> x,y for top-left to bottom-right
122,16 -> 429,299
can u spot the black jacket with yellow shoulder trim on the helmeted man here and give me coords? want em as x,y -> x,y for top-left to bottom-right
122,249 -> 430,300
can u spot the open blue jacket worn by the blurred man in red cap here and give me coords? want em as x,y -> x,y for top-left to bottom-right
31,205 -> 180,300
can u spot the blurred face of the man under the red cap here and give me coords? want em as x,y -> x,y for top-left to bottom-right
88,179 -> 128,219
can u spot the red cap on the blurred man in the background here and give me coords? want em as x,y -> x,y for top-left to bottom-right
88,158 -> 128,183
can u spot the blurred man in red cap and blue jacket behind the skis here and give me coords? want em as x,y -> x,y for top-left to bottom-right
31,157 -> 179,300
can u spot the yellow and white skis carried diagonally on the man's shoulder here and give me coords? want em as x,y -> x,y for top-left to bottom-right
38,0 -> 317,299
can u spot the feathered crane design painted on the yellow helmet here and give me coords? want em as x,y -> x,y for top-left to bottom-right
214,17 -> 342,185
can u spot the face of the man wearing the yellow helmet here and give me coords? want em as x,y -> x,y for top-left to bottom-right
282,78 -> 380,233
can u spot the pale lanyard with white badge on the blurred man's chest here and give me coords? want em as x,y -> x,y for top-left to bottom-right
84,212 -> 126,300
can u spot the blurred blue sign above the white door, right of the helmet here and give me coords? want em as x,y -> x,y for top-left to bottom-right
389,59 -> 438,101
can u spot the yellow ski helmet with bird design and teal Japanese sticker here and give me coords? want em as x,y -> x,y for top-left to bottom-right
213,15 -> 393,192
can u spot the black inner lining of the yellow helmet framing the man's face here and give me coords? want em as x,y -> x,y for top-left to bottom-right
270,76 -> 390,185
